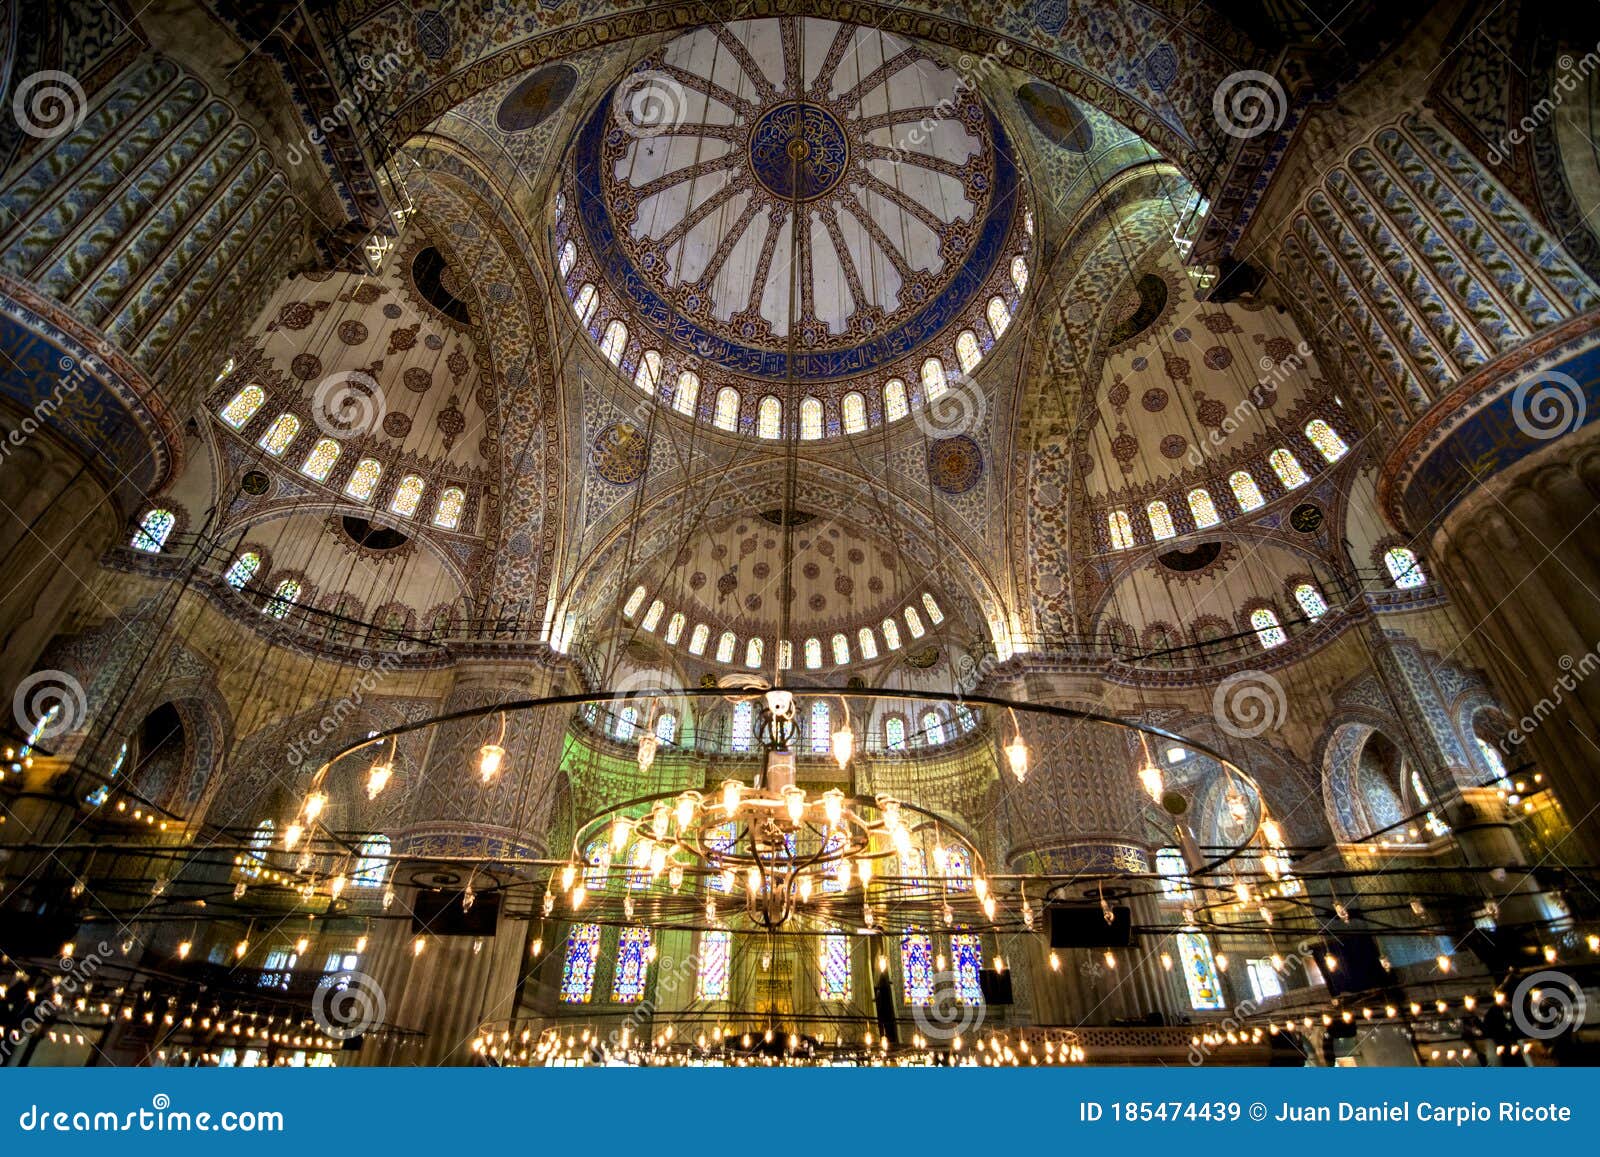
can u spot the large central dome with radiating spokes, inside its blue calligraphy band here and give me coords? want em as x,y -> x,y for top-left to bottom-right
558,18 -> 1027,381
